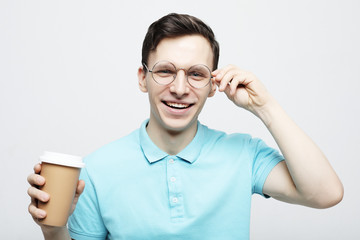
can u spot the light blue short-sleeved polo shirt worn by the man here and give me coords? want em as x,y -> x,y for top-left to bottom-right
68,120 -> 283,240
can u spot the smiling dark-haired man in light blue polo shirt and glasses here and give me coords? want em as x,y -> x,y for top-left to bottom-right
28,14 -> 343,239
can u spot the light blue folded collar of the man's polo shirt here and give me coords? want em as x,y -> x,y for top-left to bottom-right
139,119 -> 205,163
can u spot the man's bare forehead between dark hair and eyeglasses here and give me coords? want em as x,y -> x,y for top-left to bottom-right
149,35 -> 213,69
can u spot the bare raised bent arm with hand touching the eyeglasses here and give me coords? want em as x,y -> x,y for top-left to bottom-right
213,65 -> 343,208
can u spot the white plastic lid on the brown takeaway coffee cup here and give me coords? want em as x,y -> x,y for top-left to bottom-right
39,151 -> 85,168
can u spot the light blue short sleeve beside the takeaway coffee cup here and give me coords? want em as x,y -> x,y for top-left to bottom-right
68,168 -> 107,240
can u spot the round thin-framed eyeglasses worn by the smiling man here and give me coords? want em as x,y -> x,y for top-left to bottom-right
143,61 -> 212,88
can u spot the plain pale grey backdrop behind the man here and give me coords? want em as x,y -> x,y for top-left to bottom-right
0,0 -> 360,240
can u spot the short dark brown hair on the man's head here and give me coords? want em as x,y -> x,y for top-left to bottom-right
142,13 -> 220,70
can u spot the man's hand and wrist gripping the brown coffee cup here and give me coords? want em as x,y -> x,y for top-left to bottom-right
27,164 -> 85,240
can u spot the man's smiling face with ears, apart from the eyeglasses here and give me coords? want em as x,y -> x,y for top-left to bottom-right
138,35 -> 216,132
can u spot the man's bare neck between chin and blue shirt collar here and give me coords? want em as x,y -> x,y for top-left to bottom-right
146,117 -> 197,155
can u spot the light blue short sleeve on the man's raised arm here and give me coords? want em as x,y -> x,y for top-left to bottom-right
251,139 -> 284,198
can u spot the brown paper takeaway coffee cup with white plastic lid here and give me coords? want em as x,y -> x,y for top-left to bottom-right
38,152 -> 85,226
